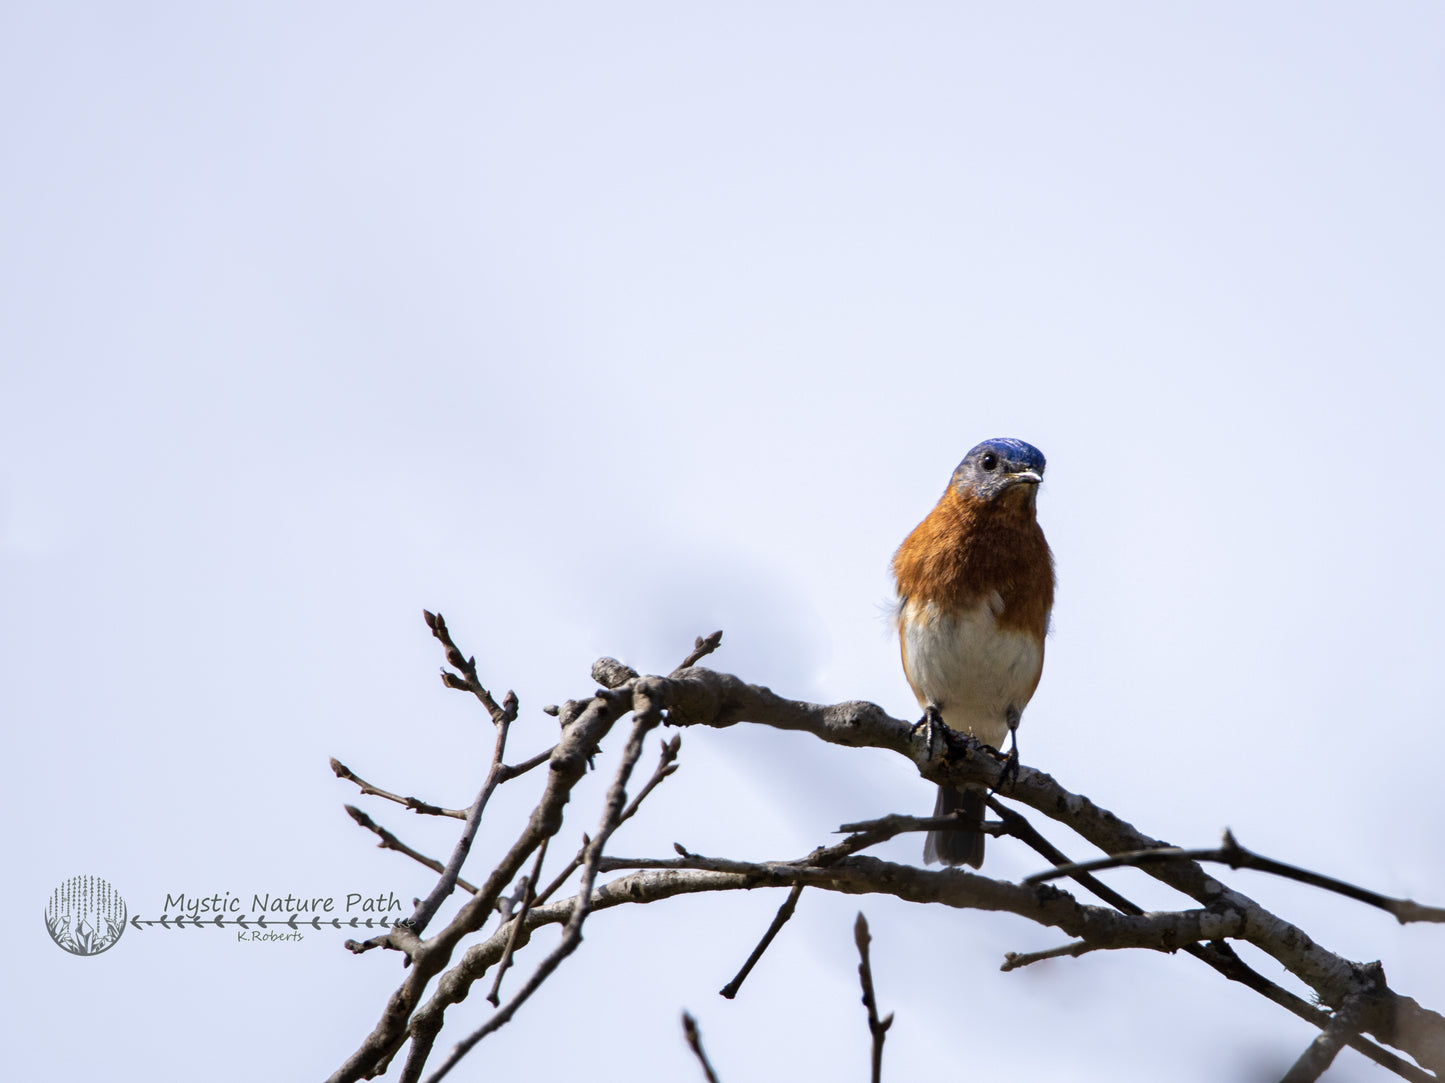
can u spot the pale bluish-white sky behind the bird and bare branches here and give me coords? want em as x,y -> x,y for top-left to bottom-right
0,3 -> 1445,1082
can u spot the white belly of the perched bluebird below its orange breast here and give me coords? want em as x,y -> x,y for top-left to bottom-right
899,602 -> 1043,748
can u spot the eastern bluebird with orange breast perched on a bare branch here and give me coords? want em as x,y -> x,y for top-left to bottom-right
893,440 -> 1053,869
